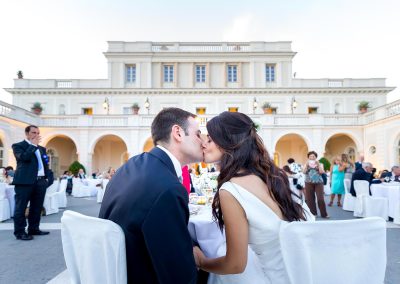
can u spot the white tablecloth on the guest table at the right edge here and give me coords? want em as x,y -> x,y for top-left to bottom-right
371,182 -> 400,224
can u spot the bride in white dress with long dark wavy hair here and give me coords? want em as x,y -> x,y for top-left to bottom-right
193,112 -> 306,284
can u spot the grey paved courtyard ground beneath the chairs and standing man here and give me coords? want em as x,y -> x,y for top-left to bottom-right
0,197 -> 400,284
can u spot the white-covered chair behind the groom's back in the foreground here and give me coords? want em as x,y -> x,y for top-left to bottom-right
61,210 -> 127,284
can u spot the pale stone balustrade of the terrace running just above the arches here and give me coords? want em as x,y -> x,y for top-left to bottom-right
0,100 -> 400,129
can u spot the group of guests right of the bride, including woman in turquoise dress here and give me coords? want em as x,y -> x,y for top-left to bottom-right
283,151 -> 400,218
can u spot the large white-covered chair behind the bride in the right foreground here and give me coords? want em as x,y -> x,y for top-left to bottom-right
279,217 -> 386,284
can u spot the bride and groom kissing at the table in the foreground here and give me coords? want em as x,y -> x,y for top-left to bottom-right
99,108 -> 307,284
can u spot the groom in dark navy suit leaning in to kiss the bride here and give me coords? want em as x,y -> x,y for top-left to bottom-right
99,108 -> 203,284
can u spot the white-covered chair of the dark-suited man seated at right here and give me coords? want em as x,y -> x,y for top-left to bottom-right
354,180 -> 389,220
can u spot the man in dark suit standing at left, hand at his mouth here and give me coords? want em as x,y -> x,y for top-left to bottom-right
12,125 -> 52,241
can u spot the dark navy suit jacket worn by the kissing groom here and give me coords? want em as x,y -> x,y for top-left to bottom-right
99,147 -> 197,284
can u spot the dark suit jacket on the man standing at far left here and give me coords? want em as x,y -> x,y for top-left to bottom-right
11,140 -> 54,185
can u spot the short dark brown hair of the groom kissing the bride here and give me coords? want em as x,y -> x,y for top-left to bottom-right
151,107 -> 196,145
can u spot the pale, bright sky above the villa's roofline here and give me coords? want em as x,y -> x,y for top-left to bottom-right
0,0 -> 400,103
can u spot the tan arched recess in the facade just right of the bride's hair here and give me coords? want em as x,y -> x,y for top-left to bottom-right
273,132 -> 310,167
